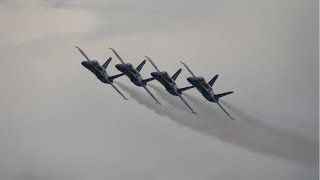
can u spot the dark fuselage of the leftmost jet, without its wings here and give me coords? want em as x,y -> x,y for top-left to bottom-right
81,60 -> 113,84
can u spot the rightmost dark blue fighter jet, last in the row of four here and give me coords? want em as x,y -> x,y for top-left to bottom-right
180,61 -> 234,120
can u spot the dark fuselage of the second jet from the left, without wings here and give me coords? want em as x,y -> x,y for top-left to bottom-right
116,63 -> 147,87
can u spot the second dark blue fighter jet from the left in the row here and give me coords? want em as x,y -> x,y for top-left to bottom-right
109,48 -> 160,104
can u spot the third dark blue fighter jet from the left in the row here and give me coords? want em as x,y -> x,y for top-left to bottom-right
145,56 -> 196,114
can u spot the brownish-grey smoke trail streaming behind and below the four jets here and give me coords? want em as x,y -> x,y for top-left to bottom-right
118,83 -> 318,165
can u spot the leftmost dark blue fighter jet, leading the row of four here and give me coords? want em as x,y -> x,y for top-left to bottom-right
75,46 -> 128,100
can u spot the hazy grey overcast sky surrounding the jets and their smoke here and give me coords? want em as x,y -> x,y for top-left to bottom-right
0,0 -> 319,180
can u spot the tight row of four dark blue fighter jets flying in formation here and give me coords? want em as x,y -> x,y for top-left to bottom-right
75,46 -> 234,120
